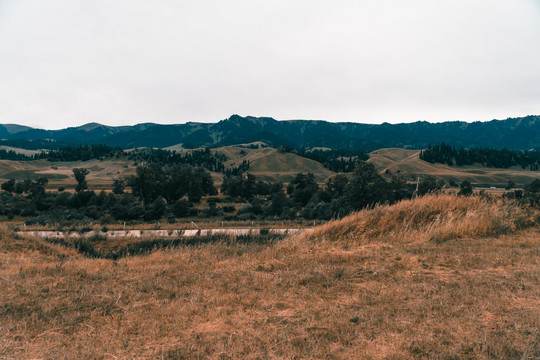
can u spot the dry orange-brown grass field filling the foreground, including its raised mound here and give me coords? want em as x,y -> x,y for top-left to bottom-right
0,195 -> 540,359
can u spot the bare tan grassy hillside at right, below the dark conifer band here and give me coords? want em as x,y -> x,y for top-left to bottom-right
369,148 -> 540,186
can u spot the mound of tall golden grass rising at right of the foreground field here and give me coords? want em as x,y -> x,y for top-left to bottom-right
309,195 -> 538,243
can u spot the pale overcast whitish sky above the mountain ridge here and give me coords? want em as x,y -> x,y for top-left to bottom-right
0,0 -> 540,129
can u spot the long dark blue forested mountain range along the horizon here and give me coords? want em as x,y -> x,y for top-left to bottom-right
0,115 -> 540,151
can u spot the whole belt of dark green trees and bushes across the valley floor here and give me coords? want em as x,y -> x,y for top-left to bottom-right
4,161 -> 540,225
